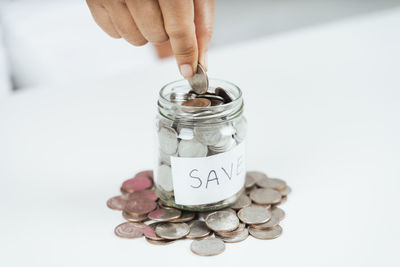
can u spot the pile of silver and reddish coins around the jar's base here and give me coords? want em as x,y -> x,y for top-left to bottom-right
107,171 -> 291,256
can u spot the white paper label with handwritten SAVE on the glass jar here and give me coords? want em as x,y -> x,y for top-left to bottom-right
171,142 -> 246,205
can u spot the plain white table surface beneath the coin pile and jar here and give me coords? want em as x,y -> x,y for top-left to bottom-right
0,9 -> 400,267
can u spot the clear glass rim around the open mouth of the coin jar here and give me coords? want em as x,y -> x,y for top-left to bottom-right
159,78 -> 243,112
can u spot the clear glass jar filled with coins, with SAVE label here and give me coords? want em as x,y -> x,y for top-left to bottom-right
155,79 -> 247,211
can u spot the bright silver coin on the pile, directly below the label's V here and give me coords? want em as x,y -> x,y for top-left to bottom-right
206,210 -> 239,232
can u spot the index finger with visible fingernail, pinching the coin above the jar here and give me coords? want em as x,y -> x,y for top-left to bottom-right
159,0 -> 198,78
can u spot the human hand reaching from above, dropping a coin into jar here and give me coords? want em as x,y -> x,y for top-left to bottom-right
86,0 -> 214,78
